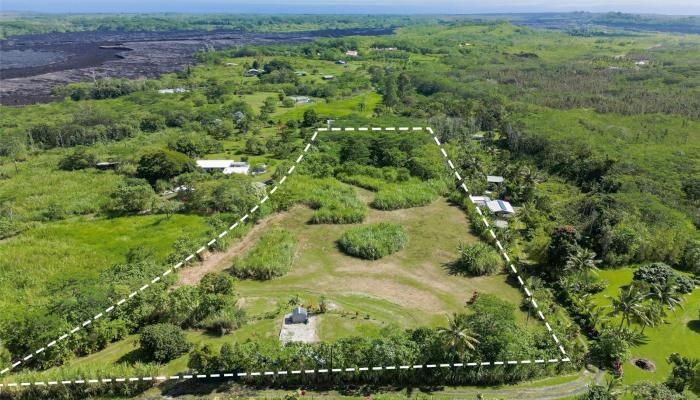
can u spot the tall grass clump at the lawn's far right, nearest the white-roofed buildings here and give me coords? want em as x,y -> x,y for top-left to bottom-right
370,180 -> 445,210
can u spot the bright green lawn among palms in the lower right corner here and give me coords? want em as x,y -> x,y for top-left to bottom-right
595,268 -> 700,384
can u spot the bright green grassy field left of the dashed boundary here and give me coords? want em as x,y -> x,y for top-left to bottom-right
0,215 -> 207,313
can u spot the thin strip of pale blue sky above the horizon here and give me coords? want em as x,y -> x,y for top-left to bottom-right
0,0 -> 700,15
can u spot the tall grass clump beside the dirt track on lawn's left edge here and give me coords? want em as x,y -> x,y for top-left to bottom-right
232,230 -> 297,280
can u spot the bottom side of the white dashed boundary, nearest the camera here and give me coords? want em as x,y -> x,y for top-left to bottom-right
0,358 -> 569,389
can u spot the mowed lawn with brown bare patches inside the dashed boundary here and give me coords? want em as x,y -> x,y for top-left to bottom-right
232,189 -> 522,334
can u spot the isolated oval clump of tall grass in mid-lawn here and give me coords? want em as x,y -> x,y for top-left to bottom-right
338,222 -> 408,260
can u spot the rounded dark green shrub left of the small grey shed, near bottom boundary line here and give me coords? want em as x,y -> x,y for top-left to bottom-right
139,324 -> 190,363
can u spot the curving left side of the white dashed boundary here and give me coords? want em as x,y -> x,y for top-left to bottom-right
0,129 -> 320,376
